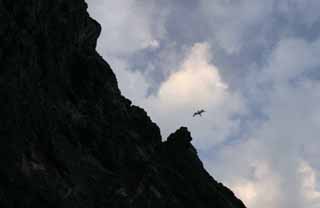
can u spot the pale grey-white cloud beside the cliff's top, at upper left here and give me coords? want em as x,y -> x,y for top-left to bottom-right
89,0 -> 165,58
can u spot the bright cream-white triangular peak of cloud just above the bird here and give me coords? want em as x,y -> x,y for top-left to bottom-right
152,44 -> 228,107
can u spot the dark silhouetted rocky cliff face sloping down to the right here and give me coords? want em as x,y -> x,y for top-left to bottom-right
0,0 -> 244,208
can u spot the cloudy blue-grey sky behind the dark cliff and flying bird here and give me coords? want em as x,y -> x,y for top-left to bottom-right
87,0 -> 320,208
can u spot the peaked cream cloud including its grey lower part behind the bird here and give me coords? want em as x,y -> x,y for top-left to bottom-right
138,43 -> 243,149
